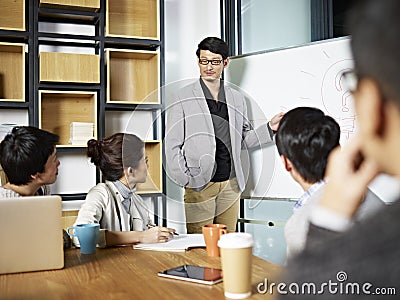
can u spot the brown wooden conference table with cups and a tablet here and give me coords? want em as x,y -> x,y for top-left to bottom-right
0,247 -> 282,300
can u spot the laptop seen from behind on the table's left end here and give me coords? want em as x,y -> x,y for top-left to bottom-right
0,196 -> 64,274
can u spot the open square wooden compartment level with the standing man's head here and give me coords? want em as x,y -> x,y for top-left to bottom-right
106,49 -> 160,104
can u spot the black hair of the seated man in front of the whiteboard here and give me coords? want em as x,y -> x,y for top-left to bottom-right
276,107 -> 340,183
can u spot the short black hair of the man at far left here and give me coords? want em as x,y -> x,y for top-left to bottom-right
0,126 -> 59,185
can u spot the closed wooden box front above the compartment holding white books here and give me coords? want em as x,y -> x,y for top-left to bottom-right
39,52 -> 100,84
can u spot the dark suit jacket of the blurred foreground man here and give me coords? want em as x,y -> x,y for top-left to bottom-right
275,201 -> 400,300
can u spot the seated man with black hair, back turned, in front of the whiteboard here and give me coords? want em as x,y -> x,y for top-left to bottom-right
276,107 -> 384,257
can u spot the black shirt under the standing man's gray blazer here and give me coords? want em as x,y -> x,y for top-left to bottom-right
200,78 -> 232,182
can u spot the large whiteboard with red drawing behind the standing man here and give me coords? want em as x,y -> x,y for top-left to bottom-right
225,37 -> 400,202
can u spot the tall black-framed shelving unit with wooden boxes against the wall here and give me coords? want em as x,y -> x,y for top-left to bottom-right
0,0 -> 166,225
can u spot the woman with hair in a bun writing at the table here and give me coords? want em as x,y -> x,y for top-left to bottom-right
74,133 -> 175,247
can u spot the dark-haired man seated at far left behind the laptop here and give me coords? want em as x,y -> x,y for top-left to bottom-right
0,126 -> 60,198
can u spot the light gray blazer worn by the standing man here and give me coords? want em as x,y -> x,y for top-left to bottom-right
165,79 -> 272,191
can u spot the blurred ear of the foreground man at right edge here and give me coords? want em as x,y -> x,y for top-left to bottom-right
356,78 -> 385,136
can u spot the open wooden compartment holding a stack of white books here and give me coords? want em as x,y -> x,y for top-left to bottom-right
39,91 -> 97,147
